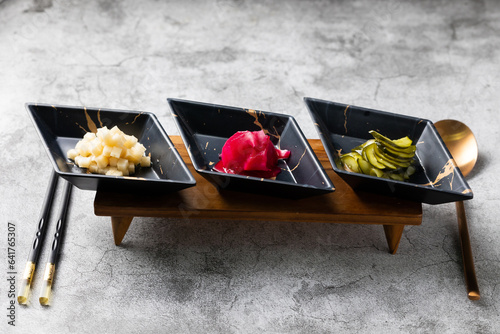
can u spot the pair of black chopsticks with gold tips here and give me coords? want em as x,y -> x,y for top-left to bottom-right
17,171 -> 72,305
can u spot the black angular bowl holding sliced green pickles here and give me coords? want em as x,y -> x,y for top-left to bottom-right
304,97 -> 473,204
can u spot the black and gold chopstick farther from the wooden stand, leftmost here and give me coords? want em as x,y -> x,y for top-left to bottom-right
17,170 -> 59,304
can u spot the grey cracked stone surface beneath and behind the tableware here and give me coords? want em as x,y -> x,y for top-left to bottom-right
0,0 -> 500,333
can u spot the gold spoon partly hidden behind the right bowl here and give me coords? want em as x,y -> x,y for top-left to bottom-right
434,119 -> 481,300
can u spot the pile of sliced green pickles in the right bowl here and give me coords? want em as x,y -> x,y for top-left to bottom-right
336,130 -> 416,181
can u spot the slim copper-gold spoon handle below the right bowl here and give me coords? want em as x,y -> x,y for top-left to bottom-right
455,201 -> 481,300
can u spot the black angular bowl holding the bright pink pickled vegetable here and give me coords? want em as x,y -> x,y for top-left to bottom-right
168,99 -> 335,199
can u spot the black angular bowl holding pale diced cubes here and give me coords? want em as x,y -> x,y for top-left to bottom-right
26,103 -> 196,194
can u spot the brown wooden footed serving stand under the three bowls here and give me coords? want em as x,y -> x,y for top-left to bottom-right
94,136 -> 422,254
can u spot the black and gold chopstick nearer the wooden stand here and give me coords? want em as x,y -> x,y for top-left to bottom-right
39,181 -> 73,305
